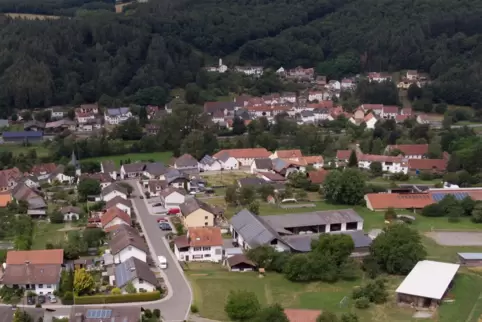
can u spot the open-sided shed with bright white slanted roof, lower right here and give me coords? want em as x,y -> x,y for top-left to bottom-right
395,260 -> 460,308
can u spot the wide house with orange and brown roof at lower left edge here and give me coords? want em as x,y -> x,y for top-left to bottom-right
0,249 -> 64,295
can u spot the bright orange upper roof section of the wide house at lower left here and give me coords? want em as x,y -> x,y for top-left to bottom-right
6,249 -> 64,265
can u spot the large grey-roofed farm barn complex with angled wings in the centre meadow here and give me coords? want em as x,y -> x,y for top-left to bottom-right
230,209 -> 371,256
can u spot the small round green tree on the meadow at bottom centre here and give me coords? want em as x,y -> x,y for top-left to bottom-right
224,291 -> 260,321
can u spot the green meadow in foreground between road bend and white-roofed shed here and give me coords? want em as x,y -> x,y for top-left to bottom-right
186,263 -> 413,322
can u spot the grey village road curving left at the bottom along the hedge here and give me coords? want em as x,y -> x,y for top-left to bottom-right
7,181 -> 192,322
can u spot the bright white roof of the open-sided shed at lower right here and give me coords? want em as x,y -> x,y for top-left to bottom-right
395,260 -> 460,300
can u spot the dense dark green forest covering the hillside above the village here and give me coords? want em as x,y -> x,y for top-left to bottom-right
0,0 -> 482,112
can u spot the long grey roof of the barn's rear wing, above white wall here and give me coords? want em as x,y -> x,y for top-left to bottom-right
263,209 -> 363,230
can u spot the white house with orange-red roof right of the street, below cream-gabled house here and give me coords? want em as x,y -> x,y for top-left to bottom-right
174,227 -> 223,263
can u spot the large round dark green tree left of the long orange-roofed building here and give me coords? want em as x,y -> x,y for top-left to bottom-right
323,169 -> 365,205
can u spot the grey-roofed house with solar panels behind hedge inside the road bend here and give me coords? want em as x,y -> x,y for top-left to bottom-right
109,257 -> 158,293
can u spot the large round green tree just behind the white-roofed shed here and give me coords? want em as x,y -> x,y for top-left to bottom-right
370,224 -> 427,274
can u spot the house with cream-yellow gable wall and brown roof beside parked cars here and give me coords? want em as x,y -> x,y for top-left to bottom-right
179,198 -> 216,228
